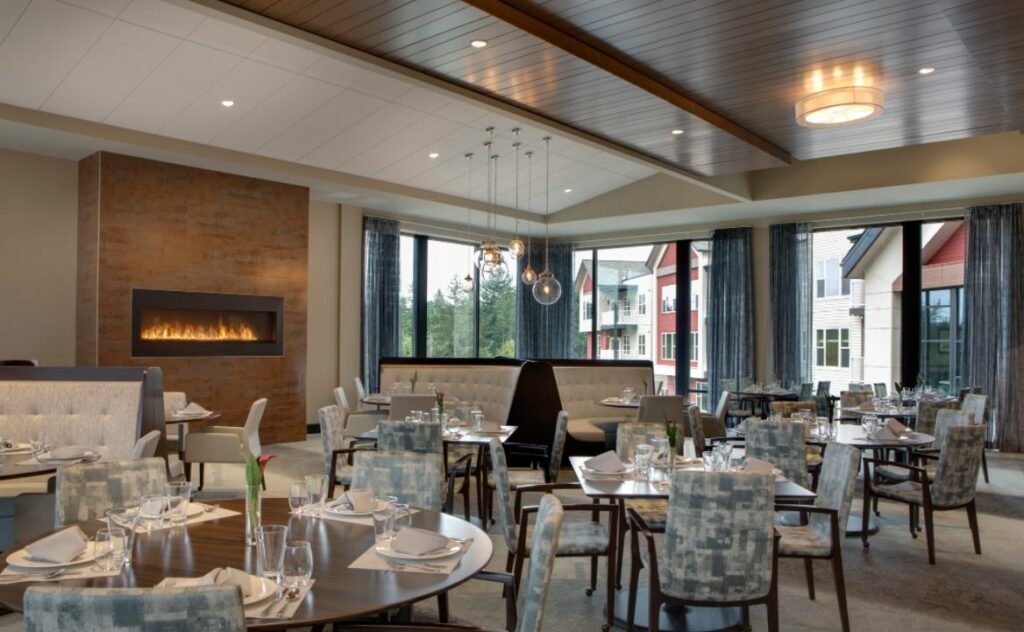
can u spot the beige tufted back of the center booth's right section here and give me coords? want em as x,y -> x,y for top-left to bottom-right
554,365 -> 654,420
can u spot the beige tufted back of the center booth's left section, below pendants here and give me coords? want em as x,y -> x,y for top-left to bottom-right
380,364 -> 522,424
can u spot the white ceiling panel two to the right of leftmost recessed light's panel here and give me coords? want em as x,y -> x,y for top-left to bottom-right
259,90 -> 387,161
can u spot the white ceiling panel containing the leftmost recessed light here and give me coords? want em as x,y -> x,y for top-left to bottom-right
161,59 -> 295,142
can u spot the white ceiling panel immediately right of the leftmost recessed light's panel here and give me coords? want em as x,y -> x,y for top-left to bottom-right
213,75 -> 341,153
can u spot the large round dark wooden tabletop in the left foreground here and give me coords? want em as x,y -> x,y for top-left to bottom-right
0,498 -> 494,630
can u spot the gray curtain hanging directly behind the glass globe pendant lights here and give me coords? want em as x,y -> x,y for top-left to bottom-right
515,243 -> 575,359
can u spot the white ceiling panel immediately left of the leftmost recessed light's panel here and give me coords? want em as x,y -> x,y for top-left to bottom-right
105,42 -> 242,132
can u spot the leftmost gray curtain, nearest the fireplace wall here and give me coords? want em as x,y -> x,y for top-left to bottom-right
362,217 -> 401,392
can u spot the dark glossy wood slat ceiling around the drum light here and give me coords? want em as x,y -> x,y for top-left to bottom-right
218,0 -> 1024,174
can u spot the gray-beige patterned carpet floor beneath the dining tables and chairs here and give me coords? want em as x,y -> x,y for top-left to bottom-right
0,436 -> 1024,632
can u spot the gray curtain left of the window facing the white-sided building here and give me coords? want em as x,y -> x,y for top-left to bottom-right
769,223 -> 814,386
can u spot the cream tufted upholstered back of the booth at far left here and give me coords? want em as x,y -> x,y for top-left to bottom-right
0,380 -> 142,460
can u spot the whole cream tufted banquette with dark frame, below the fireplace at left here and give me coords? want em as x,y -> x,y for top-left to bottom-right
0,367 -> 164,461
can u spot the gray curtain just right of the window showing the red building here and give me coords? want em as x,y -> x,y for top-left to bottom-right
707,227 -> 755,402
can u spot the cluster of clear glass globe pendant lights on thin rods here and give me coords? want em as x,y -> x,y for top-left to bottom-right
462,127 -> 562,305
